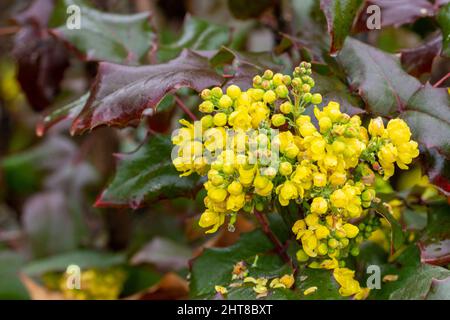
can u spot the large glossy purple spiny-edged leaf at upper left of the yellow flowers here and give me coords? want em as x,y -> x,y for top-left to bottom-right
72,50 -> 222,133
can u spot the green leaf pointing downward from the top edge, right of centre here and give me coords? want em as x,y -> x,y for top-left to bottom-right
320,0 -> 363,54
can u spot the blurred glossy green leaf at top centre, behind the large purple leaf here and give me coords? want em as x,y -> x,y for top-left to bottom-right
158,15 -> 230,61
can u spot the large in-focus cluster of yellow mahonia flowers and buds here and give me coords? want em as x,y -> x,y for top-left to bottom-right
172,62 -> 419,299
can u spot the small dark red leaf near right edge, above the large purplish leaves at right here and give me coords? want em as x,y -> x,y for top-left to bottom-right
400,34 -> 442,77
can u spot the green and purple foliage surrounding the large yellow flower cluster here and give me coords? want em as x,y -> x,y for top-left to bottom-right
0,0 -> 450,299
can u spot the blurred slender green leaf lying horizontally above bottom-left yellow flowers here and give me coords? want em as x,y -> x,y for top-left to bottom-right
22,250 -> 126,276
